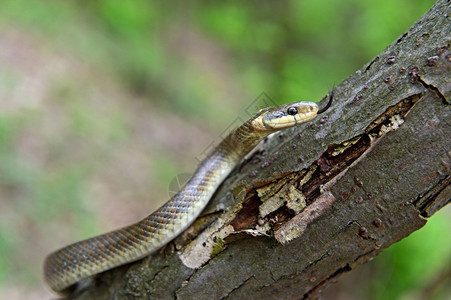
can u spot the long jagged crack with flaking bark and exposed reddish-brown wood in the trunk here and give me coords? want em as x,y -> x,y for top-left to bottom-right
223,93 -> 424,248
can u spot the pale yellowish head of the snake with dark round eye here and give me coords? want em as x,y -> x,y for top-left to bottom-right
251,101 -> 319,131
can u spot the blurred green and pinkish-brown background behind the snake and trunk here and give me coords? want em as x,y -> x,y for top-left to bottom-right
0,0 -> 451,299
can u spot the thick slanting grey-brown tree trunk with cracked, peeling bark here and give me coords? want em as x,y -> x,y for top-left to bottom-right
69,0 -> 451,299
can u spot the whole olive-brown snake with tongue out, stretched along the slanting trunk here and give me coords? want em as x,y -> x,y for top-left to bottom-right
44,93 -> 332,294
